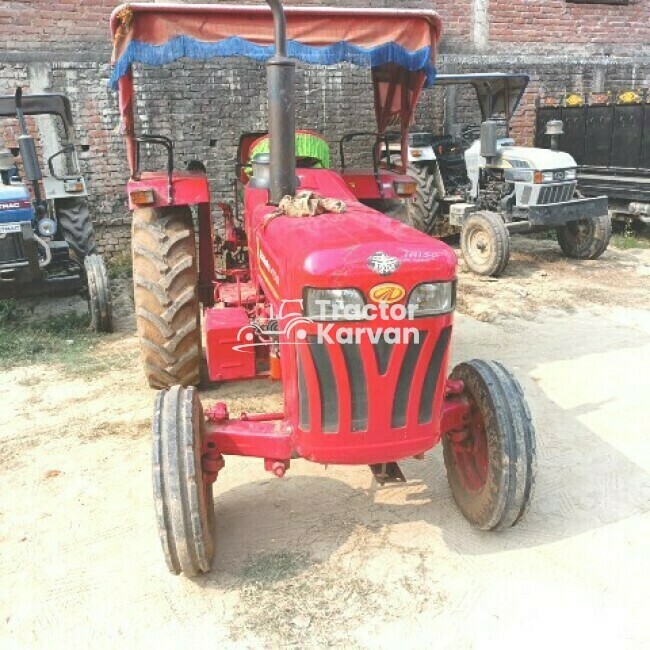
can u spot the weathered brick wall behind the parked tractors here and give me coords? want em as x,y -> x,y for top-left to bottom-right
0,0 -> 650,253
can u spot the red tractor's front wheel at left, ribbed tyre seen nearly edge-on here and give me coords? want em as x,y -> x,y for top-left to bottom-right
153,386 -> 214,576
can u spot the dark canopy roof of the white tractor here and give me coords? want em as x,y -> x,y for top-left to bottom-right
436,72 -> 530,120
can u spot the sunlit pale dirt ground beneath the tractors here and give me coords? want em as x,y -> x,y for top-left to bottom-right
0,238 -> 650,649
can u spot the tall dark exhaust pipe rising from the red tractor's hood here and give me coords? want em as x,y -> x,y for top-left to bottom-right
266,0 -> 296,205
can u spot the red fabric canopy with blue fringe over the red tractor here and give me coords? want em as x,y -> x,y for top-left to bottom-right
109,3 -> 442,171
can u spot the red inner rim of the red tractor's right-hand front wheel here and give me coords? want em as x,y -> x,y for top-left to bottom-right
450,405 -> 489,492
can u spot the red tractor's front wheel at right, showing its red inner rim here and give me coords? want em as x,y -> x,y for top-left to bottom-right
443,360 -> 536,530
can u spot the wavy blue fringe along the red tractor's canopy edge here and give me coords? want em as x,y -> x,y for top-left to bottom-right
109,36 -> 436,89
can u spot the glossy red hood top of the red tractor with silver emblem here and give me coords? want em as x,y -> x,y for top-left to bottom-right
247,170 -> 457,301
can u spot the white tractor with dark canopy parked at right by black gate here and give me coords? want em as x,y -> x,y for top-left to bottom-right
400,73 -> 611,276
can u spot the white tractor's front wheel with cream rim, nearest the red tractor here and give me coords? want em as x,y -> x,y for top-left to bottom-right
460,212 -> 510,277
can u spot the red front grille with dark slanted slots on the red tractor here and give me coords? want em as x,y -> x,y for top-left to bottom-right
298,327 -> 451,434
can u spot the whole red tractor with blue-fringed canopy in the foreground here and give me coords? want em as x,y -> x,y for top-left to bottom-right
112,0 -> 535,576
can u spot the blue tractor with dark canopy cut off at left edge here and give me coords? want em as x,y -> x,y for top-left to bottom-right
0,88 -> 112,332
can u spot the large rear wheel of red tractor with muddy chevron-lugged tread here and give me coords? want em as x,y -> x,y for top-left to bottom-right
131,207 -> 201,388
